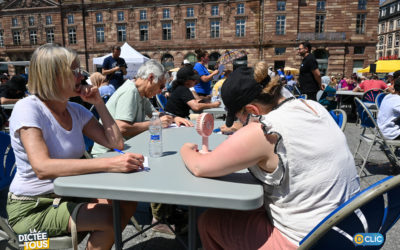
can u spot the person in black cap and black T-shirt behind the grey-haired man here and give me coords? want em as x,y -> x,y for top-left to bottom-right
165,65 -> 221,118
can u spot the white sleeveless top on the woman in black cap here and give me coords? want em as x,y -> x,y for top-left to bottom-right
249,99 -> 360,245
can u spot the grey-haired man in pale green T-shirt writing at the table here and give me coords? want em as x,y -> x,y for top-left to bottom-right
92,60 -> 192,155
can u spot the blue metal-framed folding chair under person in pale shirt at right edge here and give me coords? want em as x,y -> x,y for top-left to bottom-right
354,97 -> 400,175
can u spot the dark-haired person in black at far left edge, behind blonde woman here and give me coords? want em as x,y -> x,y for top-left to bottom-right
0,76 -> 27,104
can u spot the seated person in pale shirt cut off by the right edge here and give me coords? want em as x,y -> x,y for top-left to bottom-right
377,78 -> 400,140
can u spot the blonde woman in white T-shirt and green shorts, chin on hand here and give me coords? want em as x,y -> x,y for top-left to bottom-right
7,44 -> 143,249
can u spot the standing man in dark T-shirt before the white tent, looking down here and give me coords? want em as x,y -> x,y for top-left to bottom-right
101,46 -> 127,89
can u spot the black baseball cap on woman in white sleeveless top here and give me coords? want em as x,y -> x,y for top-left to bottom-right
221,67 -> 263,127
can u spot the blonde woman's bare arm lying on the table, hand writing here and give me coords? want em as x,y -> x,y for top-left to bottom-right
19,127 -> 144,180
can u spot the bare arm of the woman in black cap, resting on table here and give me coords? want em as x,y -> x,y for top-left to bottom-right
181,123 -> 278,177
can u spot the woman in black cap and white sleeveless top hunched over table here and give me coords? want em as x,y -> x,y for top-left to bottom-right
180,62 -> 360,249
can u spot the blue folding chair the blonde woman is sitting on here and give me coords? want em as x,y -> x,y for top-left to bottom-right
0,131 -> 81,249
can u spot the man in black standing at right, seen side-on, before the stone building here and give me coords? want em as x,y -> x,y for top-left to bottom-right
297,42 -> 324,101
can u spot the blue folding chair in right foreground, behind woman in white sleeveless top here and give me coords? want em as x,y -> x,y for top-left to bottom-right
298,175 -> 400,250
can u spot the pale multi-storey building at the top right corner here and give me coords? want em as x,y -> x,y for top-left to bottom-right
376,0 -> 400,59
